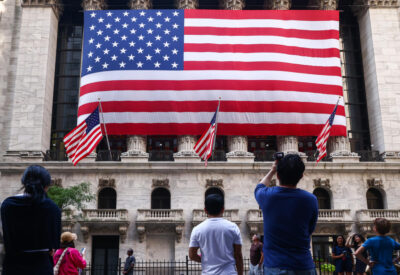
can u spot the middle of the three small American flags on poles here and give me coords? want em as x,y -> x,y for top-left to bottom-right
193,106 -> 219,166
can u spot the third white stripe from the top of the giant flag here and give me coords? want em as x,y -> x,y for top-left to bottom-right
184,52 -> 340,68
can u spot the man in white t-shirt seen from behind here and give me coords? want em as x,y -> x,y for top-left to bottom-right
189,194 -> 243,275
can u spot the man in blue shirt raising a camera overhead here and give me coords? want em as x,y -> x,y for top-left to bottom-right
254,154 -> 318,275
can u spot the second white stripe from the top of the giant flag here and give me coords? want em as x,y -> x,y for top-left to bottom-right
184,34 -> 339,49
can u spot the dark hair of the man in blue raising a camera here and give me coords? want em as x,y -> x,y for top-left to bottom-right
277,154 -> 305,186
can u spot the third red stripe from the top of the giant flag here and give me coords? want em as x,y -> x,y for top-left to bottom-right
184,43 -> 340,57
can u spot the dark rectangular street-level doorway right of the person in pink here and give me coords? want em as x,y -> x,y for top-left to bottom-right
91,236 -> 119,275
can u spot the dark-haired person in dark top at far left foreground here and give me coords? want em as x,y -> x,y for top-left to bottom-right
1,165 -> 61,275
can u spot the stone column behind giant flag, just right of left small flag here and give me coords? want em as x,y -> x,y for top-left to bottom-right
121,0 -> 151,162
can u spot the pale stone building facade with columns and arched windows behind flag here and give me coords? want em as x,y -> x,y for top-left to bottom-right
0,0 -> 400,268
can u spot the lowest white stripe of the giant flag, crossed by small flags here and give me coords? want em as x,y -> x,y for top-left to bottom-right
78,112 -> 346,125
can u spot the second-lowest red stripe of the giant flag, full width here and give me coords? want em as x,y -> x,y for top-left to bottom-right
78,100 -> 345,119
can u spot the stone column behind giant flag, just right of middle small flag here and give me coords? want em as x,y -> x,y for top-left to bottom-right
220,0 -> 254,162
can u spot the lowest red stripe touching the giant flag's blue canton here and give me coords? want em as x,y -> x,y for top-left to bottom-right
184,61 -> 342,76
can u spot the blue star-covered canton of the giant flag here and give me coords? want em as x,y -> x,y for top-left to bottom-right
82,10 -> 184,76
